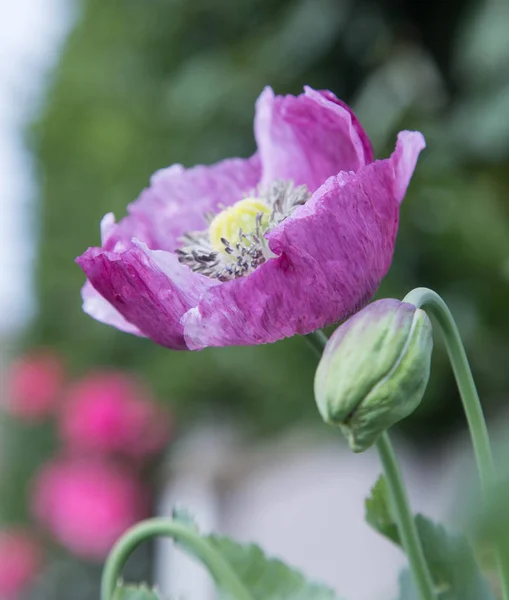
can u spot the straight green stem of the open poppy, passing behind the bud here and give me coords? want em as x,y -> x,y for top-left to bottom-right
306,331 -> 436,600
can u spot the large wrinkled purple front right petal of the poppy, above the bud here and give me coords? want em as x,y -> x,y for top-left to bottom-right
183,132 -> 424,349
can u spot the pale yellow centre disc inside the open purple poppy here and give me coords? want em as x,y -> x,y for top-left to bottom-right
209,198 -> 272,254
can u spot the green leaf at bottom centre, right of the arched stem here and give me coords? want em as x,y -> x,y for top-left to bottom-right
173,509 -> 339,600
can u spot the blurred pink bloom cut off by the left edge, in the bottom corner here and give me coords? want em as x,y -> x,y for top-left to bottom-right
0,529 -> 41,600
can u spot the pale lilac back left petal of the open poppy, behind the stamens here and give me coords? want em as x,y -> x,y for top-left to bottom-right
101,154 -> 261,252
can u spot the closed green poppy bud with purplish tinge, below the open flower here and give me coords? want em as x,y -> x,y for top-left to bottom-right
315,299 -> 433,452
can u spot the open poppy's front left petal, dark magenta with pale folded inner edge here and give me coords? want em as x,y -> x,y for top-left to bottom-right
77,240 -> 220,350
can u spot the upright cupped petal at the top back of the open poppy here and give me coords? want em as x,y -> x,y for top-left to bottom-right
255,87 -> 373,192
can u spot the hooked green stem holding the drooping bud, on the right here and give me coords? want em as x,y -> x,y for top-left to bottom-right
403,288 -> 509,600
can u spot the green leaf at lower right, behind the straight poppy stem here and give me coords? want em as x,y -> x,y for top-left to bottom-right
366,476 -> 494,600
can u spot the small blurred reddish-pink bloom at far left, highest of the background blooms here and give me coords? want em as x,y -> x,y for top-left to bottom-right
5,350 -> 64,420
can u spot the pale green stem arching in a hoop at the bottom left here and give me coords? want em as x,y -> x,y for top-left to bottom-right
101,518 -> 253,600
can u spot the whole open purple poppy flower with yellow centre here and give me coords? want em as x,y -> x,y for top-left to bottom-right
77,87 -> 425,350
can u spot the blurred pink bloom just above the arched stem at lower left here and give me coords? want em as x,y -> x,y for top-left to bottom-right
33,458 -> 148,560
